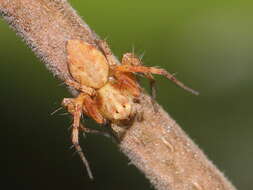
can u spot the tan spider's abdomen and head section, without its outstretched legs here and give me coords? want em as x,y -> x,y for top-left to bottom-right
63,40 -> 140,124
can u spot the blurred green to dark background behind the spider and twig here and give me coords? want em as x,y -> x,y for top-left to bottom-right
0,0 -> 253,190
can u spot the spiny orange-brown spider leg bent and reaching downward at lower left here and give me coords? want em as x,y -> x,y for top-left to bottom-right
62,94 -> 93,179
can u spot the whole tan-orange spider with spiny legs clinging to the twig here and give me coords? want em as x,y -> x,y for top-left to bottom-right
62,39 -> 198,179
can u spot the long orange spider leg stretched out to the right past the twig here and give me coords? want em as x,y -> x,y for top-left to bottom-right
115,65 -> 199,95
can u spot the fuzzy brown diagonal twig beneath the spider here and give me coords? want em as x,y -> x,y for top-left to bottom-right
0,0 -> 235,190
